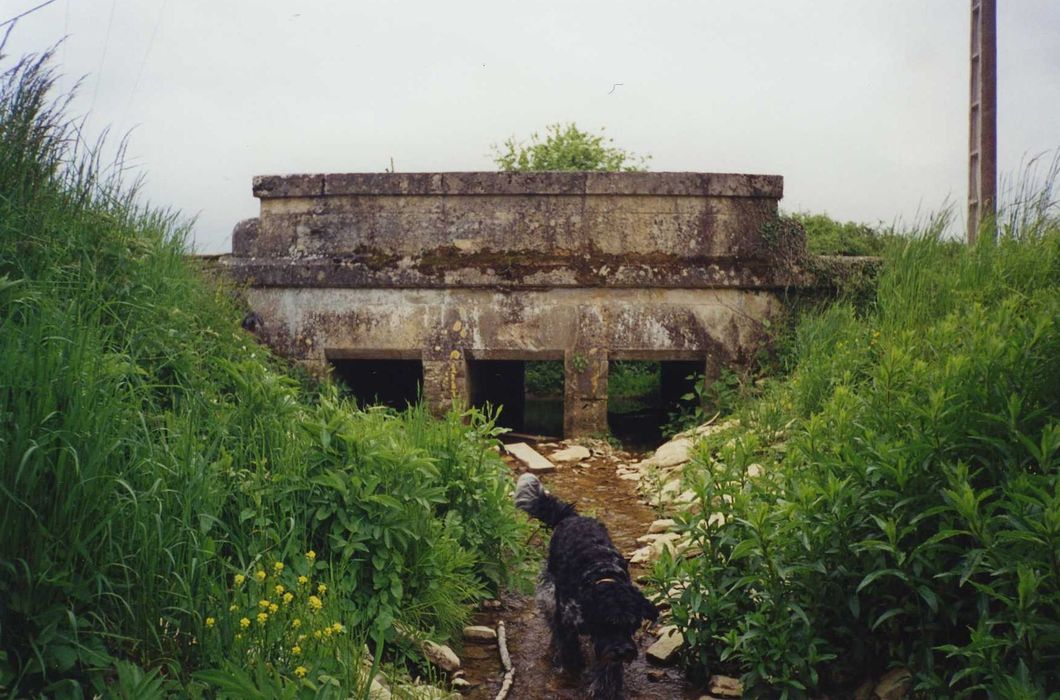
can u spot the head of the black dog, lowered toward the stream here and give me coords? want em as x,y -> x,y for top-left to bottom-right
585,579 -> 659,664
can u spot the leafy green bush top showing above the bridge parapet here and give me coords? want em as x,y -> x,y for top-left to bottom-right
493,123 -> 648,172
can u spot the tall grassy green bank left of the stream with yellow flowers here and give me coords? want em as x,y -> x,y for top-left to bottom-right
0,47 -> 525,697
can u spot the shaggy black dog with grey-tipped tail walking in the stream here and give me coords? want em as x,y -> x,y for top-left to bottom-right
515,474 -> 658,700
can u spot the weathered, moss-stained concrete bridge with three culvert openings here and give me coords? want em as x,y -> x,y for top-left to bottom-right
223,173 -> 810,437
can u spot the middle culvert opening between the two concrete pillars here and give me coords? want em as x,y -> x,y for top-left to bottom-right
467,360 -> 563,436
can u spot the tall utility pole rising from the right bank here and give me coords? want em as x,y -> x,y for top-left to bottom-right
968,0 -> 997,245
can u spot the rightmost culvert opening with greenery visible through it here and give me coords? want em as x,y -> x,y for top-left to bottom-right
607,360 -> 704,450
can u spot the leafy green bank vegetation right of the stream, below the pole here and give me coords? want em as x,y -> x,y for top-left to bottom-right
655,180 -> 1060,698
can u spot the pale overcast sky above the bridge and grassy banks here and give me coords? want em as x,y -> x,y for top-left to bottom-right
0,0 -> 1060,252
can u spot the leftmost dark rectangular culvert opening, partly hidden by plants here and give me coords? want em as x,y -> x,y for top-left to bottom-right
331,360 -> 423,410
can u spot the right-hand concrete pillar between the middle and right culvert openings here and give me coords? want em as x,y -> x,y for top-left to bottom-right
563,348 -> 607,438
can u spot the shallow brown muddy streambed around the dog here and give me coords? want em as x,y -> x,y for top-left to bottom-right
461,445 -> 702,700
